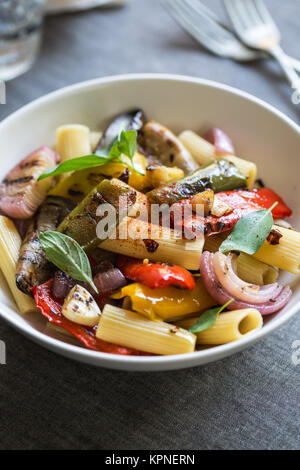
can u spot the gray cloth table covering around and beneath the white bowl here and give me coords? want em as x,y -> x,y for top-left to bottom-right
0,0 -> 300,450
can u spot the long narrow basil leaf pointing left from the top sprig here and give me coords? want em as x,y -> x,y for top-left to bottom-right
38,155 -> 110,181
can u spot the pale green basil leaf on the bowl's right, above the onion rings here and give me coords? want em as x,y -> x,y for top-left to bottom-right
219,202 -> 278,255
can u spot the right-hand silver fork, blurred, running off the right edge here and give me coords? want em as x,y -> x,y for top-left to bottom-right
224,0 -> 300,93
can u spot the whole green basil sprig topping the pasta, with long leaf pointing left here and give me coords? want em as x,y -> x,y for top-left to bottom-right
38,131 -> 143,181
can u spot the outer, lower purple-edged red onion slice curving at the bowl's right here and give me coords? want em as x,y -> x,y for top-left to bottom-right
200,251 -> 292,315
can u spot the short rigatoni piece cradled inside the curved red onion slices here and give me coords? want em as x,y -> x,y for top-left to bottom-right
237,253 -> 279,286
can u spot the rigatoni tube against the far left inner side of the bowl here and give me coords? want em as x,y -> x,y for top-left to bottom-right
0,216 -> 36,314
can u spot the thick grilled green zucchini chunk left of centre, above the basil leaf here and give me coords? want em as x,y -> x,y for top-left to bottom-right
57,179 -> 136,250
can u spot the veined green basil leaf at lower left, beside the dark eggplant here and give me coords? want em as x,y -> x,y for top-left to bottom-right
39,231 -> 98,294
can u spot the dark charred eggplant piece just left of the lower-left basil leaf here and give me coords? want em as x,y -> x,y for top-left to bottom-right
16,196 -> 74,295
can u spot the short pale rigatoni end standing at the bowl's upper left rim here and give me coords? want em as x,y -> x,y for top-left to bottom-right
56,124 -> 92,162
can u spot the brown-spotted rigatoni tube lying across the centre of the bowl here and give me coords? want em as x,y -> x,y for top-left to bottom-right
100,217 -> 204,271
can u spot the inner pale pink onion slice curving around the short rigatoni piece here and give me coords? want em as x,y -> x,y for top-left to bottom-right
213,252 -> 282,304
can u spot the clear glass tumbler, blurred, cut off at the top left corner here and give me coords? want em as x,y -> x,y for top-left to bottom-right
0,0 -> 45,80
